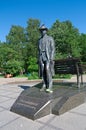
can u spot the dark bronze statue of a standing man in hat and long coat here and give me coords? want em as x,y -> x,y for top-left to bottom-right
38,25 -> 55,93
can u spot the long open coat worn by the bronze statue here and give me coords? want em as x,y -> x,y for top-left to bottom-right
38,34 -> 55,77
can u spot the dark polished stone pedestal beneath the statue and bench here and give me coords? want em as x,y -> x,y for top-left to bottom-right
11,82 -> 86,120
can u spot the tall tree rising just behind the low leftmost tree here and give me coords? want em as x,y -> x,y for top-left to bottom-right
6,25 -> 26,71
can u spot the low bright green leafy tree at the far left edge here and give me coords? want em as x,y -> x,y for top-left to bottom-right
0,43 -> 23,75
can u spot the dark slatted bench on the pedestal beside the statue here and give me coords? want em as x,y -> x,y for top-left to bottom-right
55,58 -> 83,88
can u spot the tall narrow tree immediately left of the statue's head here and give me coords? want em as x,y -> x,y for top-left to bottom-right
26,19 -> 40,71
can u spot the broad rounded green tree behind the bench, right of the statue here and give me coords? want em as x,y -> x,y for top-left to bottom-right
49,20 -> 80,58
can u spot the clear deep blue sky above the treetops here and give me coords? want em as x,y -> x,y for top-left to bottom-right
0,0 -> 86,41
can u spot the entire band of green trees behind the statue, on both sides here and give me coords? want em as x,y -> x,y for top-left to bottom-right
0,18 -> 86,75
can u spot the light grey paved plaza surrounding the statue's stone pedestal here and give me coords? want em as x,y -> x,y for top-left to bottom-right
0,76 -> 86,130
